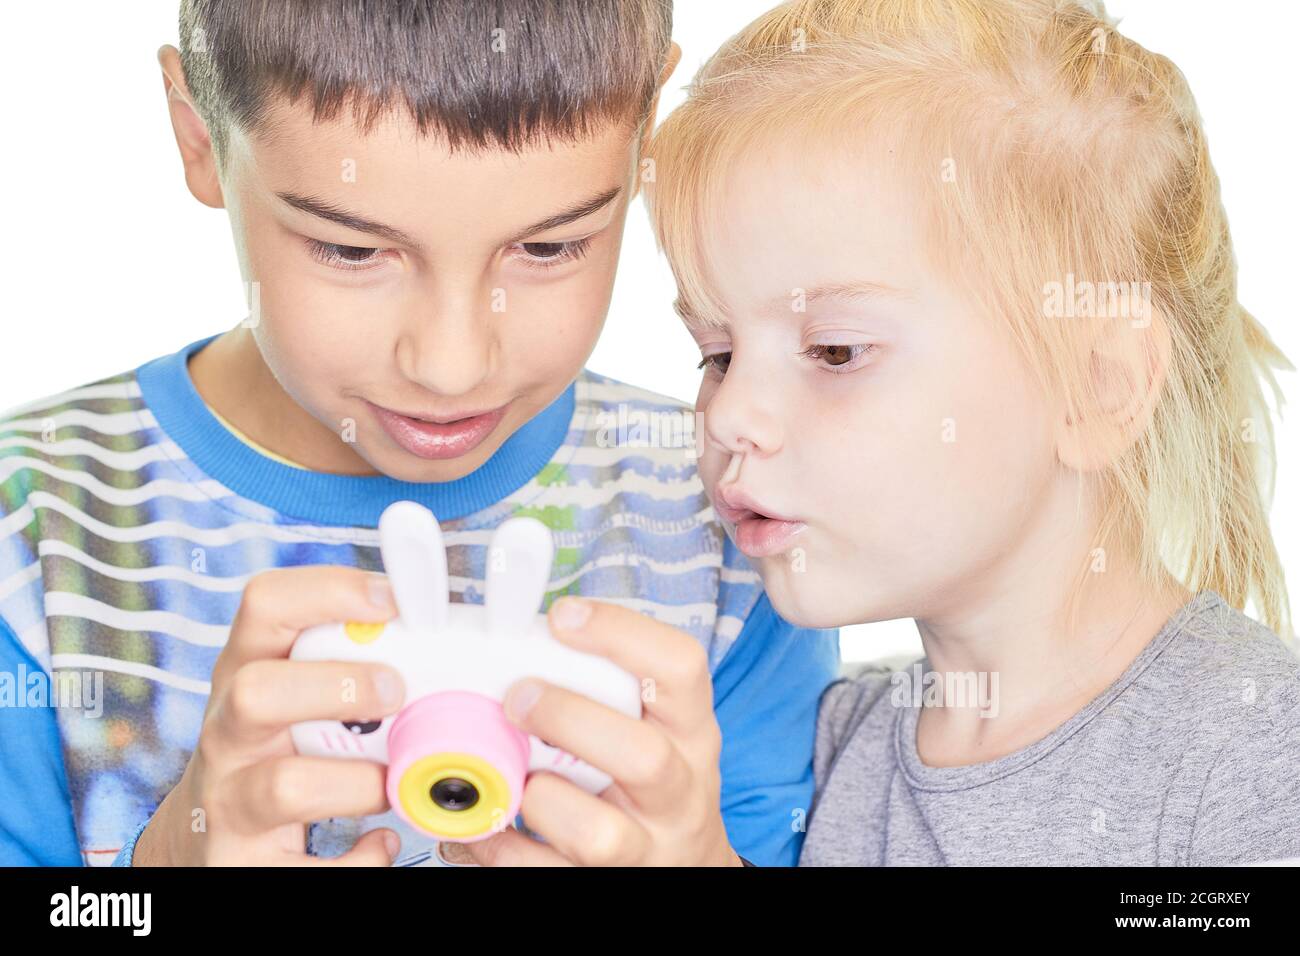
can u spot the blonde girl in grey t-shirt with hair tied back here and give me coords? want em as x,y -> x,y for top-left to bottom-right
649,0 -> 1300,865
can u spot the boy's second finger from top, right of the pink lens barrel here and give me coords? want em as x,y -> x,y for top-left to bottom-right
506,678 -> 696,816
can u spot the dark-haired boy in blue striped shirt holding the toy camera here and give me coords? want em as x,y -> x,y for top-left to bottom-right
0,0 -> 837,865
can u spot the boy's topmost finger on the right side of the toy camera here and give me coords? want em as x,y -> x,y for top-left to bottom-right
546,597 -> 714,734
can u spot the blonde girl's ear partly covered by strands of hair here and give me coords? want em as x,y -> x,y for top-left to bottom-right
1057,294 -> 1170,472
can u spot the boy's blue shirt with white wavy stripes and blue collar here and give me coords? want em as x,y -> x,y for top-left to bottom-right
0,338 -> 839,865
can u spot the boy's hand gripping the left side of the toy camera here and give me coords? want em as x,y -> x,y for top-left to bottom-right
133,566 -> 404,866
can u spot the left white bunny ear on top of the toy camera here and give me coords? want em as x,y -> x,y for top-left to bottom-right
380,501 -> 449,630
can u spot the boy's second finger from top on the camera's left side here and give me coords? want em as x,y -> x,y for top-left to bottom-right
211,661 -> 406,747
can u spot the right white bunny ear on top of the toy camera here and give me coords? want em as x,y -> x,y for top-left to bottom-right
484,518 -> 555,635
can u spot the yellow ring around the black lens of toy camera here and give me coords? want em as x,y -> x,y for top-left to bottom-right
398,753 -> 511,839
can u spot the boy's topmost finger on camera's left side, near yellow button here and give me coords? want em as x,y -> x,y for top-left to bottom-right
212,564 -> 397,684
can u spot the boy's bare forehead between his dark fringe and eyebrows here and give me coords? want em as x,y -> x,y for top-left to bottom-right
231,98 -> 637,238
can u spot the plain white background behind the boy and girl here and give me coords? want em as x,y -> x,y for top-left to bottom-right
0,0 -> 1300,659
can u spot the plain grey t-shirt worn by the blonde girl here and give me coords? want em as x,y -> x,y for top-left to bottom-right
800,591 -> 1300,866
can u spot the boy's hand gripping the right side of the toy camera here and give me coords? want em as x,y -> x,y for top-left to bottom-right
443,597 -> 742,866
